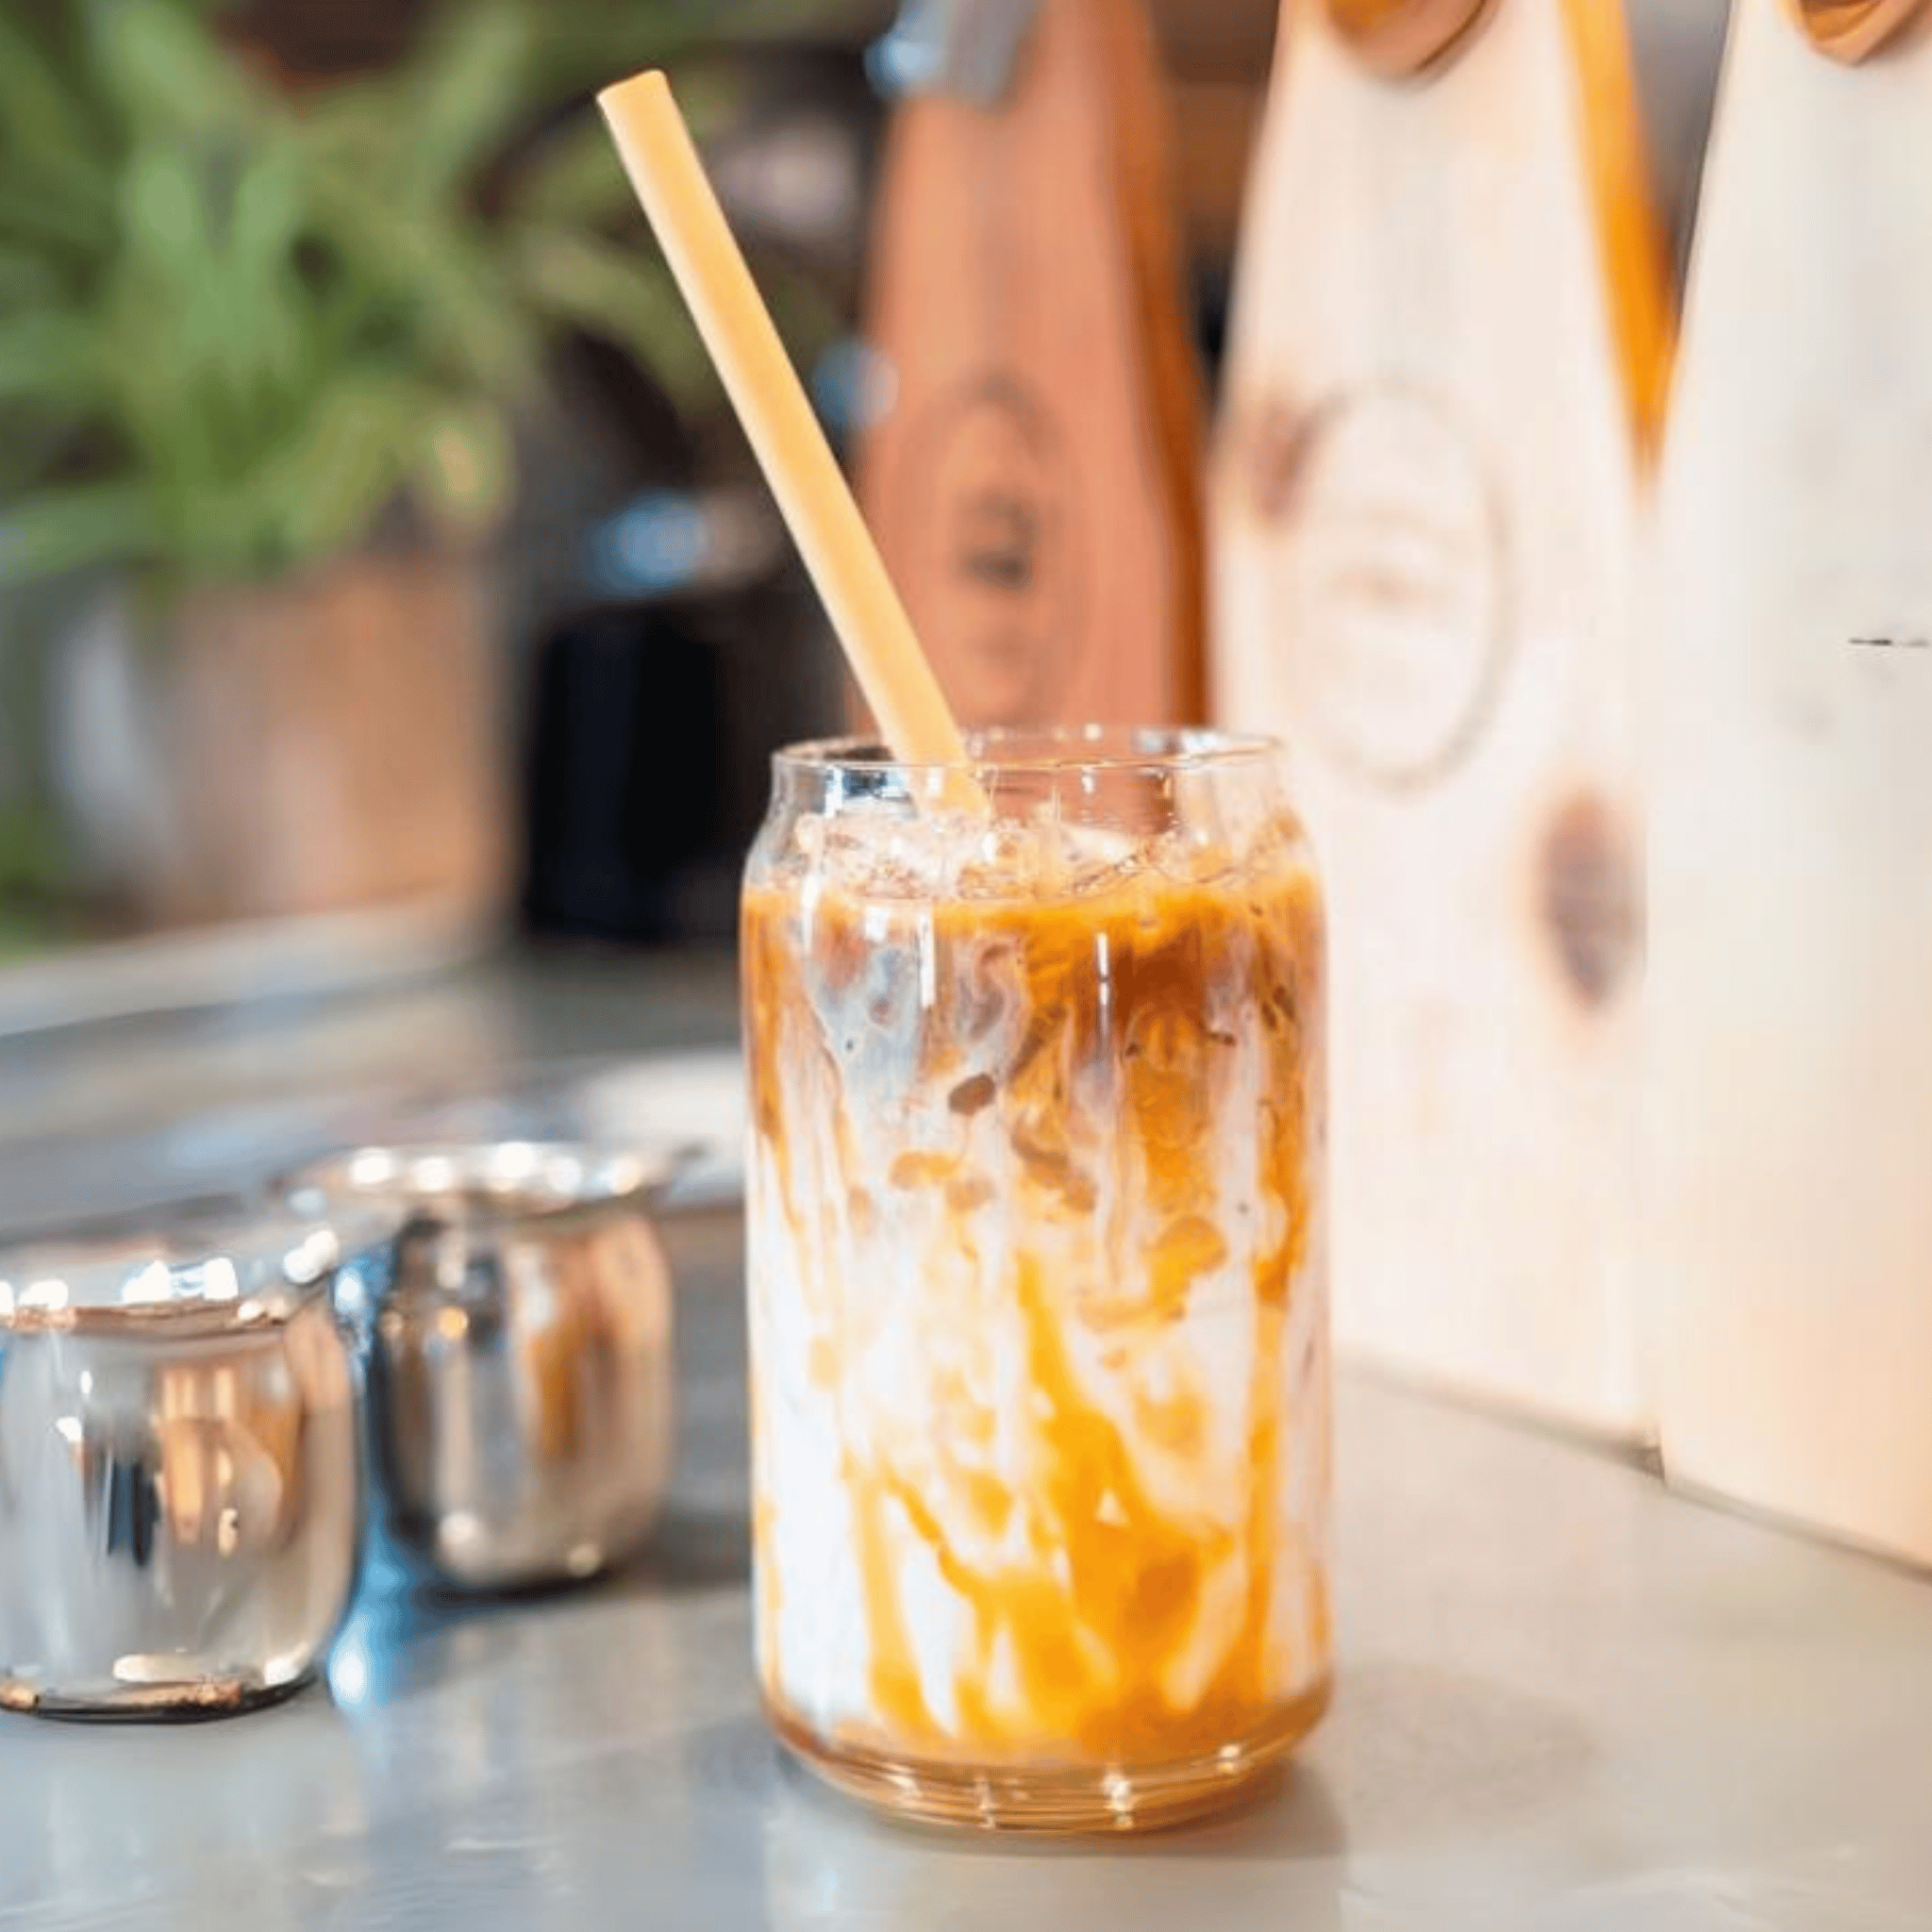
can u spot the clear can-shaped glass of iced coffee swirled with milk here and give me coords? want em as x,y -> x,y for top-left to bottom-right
741,728 -> 1331,1829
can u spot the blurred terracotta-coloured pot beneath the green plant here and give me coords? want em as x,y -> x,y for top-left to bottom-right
147,555 -> 510,925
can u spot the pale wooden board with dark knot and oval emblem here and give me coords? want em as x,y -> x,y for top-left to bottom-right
1211,0 -> 1669,1436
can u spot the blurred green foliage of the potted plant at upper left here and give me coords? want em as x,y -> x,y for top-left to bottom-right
0,0 -> 830,579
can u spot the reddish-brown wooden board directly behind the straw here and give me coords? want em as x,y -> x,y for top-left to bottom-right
859,0 -> 1202,724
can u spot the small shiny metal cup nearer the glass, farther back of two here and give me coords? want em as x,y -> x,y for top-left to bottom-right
280,1141 -> 686,1591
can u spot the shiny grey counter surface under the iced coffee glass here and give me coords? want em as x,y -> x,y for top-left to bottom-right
0,954 -> 1932,1932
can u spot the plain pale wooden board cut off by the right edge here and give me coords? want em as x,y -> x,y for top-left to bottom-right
1644,0 -> 1932,1563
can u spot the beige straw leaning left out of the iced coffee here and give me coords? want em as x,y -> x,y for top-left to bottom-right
597,72 -> 979,802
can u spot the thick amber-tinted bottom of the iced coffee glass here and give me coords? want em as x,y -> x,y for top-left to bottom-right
765,1677 -> 1331,1836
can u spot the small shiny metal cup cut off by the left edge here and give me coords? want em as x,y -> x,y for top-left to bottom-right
0,1204 -> 363,1718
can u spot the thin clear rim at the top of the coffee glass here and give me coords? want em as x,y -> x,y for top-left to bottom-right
771,724 -> 1283,776
